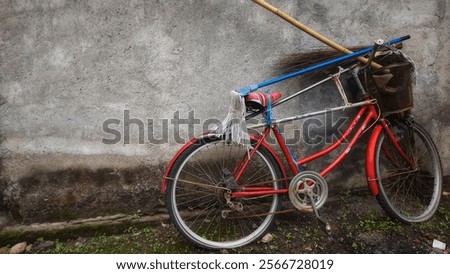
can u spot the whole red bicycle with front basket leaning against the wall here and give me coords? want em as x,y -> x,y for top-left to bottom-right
161,37 -> 442,249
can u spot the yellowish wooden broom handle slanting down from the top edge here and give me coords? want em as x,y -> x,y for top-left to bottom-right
252,0 -> 381,69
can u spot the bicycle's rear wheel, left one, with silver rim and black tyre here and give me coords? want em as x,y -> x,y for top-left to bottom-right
166,137 -> 281,249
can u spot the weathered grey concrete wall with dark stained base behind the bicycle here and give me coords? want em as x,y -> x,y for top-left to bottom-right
0,0 -> 450,227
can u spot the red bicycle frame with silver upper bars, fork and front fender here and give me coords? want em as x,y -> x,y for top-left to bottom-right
231,69 -> 414,198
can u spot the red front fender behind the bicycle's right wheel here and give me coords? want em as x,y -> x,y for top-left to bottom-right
366,124 -> 383,196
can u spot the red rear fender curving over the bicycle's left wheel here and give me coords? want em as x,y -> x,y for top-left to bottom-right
160,133 -> 287,194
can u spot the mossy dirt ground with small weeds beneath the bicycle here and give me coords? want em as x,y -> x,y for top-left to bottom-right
7,186 -> 450,254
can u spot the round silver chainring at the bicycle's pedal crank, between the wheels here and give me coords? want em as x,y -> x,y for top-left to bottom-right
289,170 -> 328,212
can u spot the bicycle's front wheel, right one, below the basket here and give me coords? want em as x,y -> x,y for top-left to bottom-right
375,123 -> 442,223
